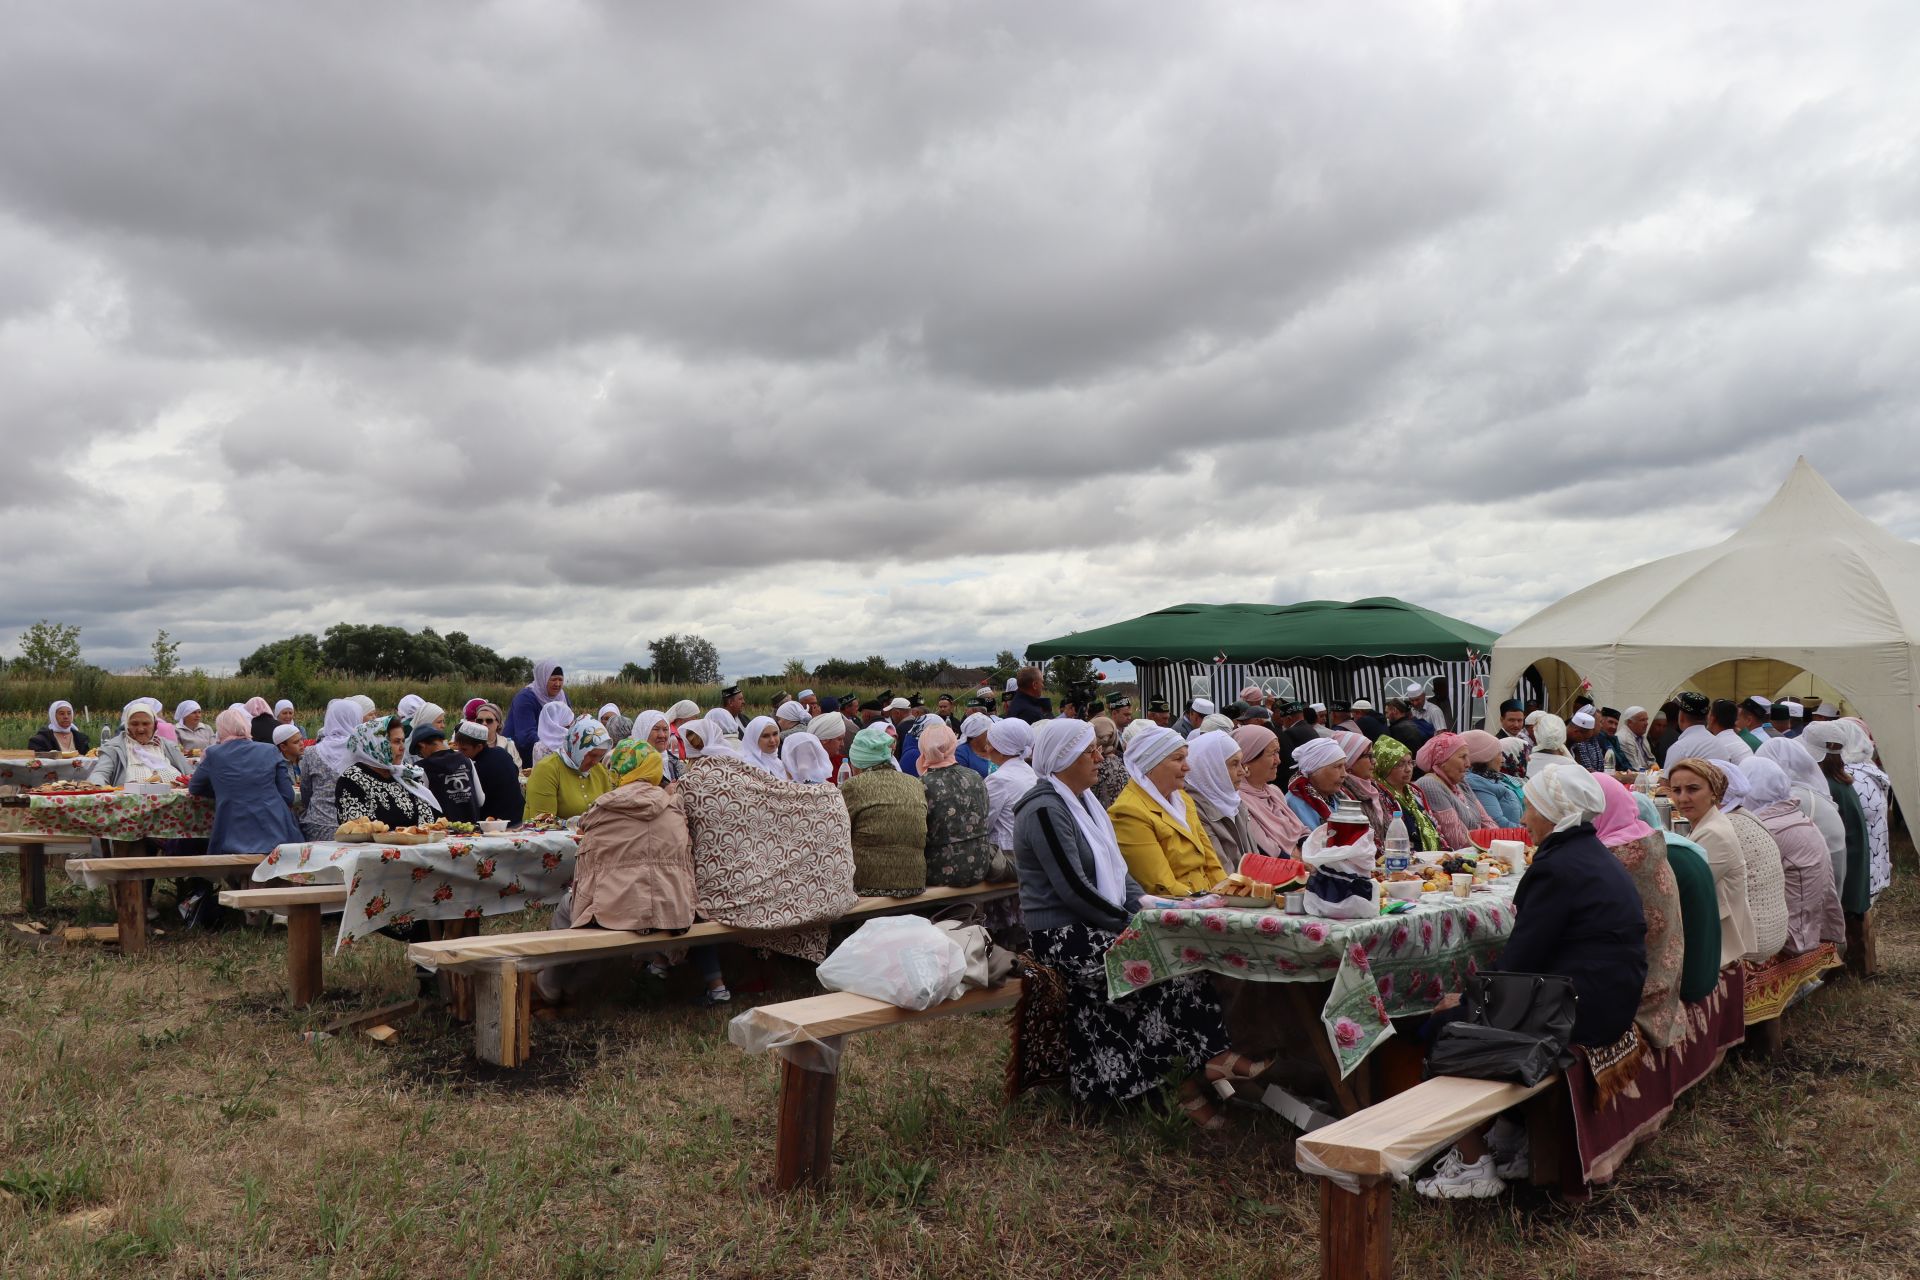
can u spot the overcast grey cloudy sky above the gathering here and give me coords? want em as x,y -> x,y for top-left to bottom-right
0,0 -> 1920,672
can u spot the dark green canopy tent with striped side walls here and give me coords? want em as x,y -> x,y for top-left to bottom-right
1027,595 -> 1500,725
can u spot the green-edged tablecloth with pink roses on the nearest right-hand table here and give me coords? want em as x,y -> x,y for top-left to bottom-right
1106,890 -> 1519,1077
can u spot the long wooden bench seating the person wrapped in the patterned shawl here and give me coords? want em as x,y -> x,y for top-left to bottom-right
407,885 -> 1018,1067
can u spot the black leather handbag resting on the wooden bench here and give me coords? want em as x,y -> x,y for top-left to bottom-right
1427,973 -> 1580,1084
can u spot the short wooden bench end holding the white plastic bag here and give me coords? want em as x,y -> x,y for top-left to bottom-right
737,979 -> 1021,1192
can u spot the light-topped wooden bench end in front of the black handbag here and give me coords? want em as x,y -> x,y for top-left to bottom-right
1294,1075 -> 1563,1280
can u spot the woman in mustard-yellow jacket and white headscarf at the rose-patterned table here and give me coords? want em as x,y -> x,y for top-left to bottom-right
1106,729 -> 1227,898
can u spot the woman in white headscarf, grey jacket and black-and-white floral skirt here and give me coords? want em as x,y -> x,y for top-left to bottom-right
998,720 -> 1227,1128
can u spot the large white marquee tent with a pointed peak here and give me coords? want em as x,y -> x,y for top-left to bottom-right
1488,459 -> 1920,812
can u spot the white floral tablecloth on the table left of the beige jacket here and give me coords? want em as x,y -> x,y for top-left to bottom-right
253,831 -> 580,950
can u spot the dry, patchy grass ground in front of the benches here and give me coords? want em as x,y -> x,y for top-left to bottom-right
0,858 -> 1920,1280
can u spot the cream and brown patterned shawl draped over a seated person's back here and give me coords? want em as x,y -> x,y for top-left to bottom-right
680,756 -> 856,961
